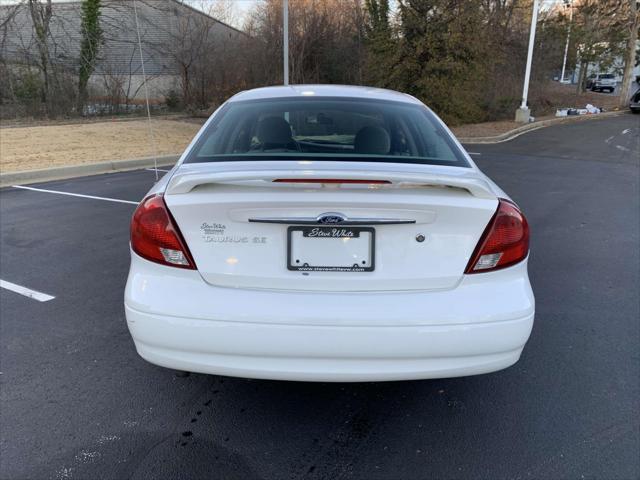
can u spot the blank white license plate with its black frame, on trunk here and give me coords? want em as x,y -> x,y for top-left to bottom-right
287,226 -> 375,272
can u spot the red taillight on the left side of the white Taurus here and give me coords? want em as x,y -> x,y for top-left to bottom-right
131,195 -> 196,270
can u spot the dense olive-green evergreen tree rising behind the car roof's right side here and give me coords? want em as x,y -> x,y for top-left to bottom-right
394,0 -> 486,124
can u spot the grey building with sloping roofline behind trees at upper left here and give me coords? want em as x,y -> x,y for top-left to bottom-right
0,0 -> 247,113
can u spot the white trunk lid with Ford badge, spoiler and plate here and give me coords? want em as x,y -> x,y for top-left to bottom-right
165,162 -> 498,291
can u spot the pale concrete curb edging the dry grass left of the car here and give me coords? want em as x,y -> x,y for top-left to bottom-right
0,155 -> 180,187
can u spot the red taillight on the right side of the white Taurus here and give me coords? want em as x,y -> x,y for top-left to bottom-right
464,198 -> 529,273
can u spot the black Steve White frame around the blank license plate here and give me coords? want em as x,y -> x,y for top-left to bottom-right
287,225 -> 376,273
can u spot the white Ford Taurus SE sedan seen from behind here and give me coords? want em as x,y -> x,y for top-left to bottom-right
125,85 -> 534,382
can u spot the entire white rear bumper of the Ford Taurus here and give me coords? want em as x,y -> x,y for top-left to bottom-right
125,251 -> 534,381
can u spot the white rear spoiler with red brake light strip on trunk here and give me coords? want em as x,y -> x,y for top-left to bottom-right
165,169 -> 496,199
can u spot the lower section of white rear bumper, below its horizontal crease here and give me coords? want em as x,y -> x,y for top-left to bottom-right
126,308 -> 533,382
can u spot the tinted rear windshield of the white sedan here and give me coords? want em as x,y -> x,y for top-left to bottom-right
185,97 -> 469,167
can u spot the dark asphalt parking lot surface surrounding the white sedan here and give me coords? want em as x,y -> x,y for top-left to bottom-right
0,114 -> 640,479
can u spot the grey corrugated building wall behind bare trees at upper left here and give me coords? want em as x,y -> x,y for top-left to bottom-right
0,0 -> 245,99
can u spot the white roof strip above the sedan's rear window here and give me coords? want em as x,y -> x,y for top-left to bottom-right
229,85 -> 422,105
